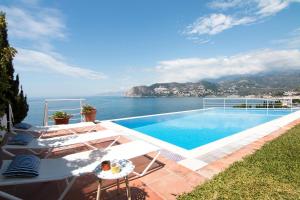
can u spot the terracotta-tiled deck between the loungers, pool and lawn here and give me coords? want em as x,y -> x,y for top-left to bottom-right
0,119 -> 300,200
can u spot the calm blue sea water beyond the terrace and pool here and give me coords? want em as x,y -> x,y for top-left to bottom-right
24,96 -> 203,125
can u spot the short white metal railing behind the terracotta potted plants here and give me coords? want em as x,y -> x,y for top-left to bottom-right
43,99 -> 85,126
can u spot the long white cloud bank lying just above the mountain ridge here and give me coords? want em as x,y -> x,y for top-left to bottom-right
155,49 -> 300,82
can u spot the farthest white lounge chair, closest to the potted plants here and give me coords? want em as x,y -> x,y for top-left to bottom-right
8,105 -> 96,138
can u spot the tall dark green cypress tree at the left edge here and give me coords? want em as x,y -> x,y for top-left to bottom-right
0,12 -> 28,123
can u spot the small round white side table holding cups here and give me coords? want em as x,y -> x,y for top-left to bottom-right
95,159 -> 135,200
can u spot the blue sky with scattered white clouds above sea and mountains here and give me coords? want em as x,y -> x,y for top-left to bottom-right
0,0 -> 300,97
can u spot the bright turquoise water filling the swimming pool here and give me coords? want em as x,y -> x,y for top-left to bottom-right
115,108 -> 291,150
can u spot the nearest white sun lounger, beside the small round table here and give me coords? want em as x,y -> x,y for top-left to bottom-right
0,141 -> 160,200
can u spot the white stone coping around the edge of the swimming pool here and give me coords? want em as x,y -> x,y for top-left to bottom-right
101,108 -> 300,171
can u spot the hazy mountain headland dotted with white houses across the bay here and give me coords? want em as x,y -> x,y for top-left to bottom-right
125,70 -> 300,97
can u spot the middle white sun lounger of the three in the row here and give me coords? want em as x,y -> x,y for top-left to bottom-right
2,130 -> 122,158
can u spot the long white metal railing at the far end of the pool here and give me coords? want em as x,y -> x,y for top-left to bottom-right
203,97 -> 300,110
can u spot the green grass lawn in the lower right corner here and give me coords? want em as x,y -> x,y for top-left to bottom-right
178,125 -> 300,200
